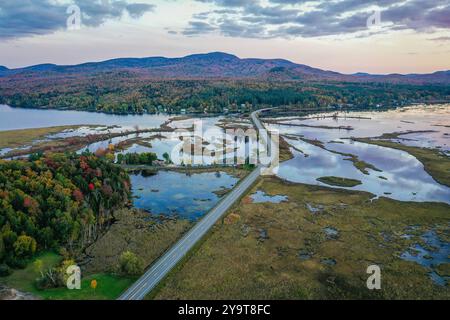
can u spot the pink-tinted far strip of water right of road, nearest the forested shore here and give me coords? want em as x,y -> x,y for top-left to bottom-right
271,104 -> 450,150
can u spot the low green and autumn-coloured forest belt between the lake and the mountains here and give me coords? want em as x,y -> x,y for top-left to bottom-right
0,73 -> 450,114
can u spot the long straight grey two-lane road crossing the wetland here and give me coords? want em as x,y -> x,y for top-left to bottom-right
119,110 -> 265,300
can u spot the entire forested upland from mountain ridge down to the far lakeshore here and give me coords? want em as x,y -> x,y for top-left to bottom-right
0,52 -> 450,114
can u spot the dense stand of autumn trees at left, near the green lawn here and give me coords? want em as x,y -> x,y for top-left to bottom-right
0,153 -> 130,268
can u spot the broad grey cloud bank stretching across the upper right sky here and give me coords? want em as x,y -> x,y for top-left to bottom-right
184,0 -> 450,38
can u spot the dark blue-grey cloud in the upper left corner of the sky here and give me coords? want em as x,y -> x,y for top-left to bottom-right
0,0 -> 155,39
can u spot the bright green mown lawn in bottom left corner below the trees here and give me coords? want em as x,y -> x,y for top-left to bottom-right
0,252 -> 137,300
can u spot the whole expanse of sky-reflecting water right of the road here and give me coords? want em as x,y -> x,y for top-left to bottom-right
270,105 -> 450,203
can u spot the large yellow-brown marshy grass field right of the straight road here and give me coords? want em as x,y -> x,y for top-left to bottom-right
154,178 -> 450,299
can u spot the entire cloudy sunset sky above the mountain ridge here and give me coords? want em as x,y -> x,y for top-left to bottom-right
0,0 -> 450,73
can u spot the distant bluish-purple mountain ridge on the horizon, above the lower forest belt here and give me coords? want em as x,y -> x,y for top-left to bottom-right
0,52 -> 450,84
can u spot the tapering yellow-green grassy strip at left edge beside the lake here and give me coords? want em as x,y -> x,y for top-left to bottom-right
0,126 -> 81,149
